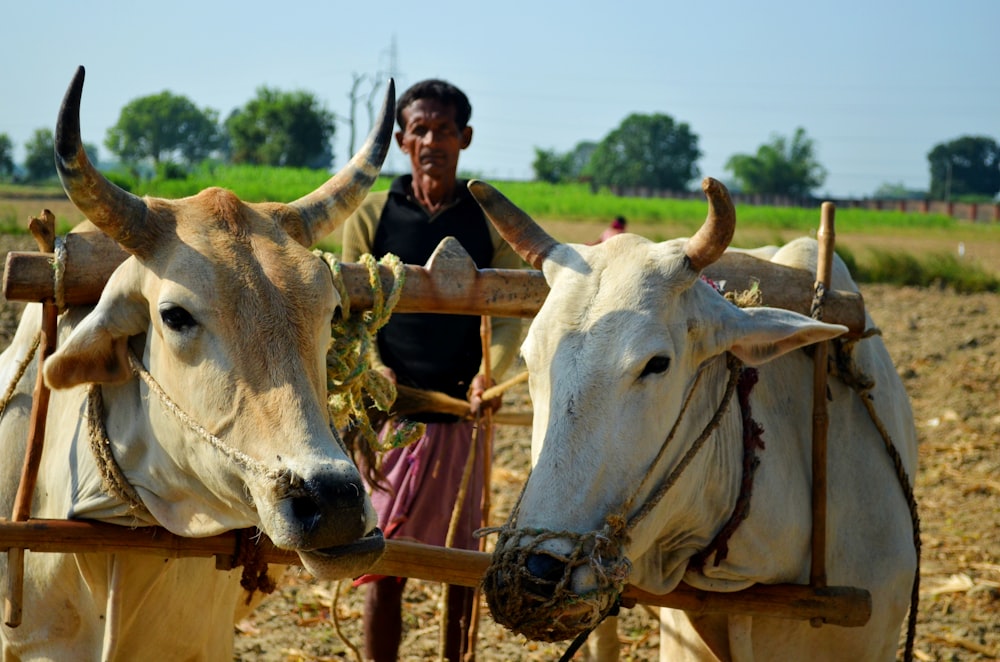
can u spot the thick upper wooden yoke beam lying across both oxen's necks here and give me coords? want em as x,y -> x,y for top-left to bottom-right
3,231 -> 865,334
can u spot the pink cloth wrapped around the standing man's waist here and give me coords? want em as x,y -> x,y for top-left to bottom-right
354,421 -> 484,585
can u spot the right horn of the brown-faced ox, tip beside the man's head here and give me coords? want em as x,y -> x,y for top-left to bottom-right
289,78 -> 396,247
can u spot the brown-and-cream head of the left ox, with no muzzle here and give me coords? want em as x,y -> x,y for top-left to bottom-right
45,67 -> 394,577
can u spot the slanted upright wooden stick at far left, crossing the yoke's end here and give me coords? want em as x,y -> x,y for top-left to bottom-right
4,209 -> 59,628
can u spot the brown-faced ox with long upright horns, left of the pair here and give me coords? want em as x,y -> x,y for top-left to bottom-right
0,67 -> 394,662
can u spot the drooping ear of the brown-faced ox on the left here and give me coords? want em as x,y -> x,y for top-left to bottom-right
45,259 -> 149,389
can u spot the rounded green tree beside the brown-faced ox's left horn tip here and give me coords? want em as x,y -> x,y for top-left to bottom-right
104,91 -> 221,169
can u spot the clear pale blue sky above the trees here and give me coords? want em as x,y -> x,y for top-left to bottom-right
0,0 -> 1000,197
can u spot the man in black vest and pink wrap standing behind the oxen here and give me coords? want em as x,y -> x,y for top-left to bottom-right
343,80 -> 522,662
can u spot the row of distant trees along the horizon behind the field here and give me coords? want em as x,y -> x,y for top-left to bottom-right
0,86 -> 1000,205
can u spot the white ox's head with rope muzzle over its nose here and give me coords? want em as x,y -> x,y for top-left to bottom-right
469,179 -> 846,640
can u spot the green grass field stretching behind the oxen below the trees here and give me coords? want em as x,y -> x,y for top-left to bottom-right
0,172 -> 1000,292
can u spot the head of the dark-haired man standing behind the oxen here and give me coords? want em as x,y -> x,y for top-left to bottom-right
396,79 -> 472,184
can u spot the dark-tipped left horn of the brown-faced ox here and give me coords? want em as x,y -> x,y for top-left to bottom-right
55,67 -> 155,256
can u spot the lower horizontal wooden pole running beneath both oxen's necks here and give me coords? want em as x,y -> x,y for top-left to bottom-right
0,519 -> 872,627
